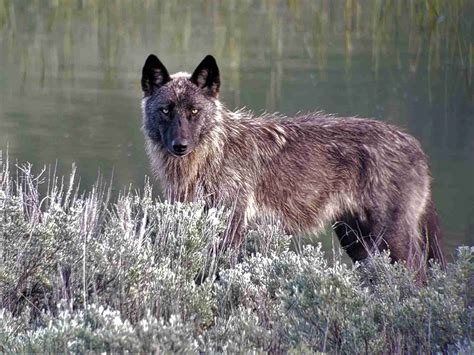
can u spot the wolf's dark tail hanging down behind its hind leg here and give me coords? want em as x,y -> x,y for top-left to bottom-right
421,197 -> 446,269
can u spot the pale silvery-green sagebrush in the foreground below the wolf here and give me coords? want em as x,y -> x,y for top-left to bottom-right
0,157 -> 474,353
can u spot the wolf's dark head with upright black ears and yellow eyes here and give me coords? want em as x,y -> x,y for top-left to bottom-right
142,54 -> 220,156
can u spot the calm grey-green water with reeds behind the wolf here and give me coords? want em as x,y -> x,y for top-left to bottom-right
0,0 -> 474,254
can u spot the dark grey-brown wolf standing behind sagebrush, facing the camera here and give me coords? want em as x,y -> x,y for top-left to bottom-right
141,54 -> 445,268
